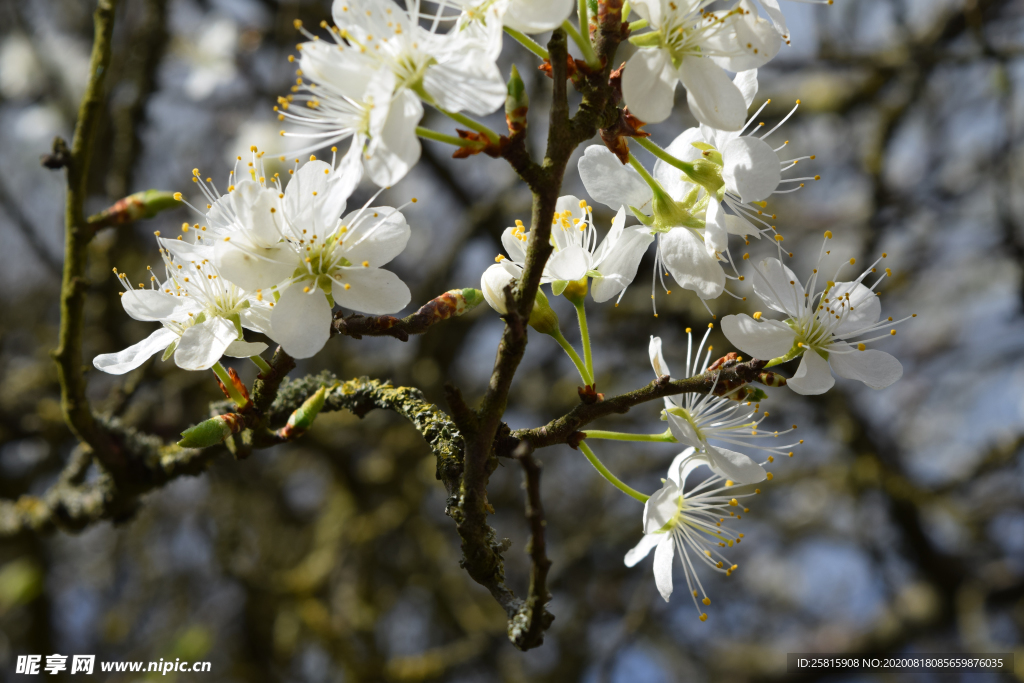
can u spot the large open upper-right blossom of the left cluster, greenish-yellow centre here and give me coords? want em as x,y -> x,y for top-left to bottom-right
177,150 -> 411,358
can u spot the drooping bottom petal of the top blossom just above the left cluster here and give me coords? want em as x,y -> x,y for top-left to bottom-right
362,90 -> 423,187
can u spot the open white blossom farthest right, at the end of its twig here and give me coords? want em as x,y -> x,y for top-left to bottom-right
722,232 -> 912,394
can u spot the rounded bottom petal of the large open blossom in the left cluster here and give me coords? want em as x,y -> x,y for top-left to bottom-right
270,285 -> 331,358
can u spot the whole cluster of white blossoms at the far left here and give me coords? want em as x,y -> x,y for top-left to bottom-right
94,147 -> 410,374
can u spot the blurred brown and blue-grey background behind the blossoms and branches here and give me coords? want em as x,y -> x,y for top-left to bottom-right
0,0 -> 1024,683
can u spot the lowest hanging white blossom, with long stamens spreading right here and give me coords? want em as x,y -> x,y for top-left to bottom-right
625,450 -> 760,622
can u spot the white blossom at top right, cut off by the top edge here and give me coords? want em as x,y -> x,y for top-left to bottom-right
623,0 -> 781,130
